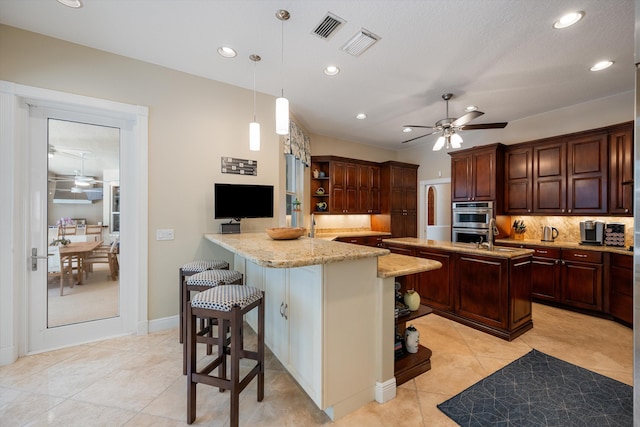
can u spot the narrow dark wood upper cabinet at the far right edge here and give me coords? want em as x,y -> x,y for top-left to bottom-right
609,123 -> 634,216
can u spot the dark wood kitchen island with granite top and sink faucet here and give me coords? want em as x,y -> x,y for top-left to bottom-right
383,241 -> 533,341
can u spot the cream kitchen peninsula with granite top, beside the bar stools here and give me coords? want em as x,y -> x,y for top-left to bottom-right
204,233 -> 440,420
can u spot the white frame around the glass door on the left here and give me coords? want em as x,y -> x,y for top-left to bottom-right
0,81 -> 149,365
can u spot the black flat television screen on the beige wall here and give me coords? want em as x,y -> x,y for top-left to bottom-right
213,183 -> 273,219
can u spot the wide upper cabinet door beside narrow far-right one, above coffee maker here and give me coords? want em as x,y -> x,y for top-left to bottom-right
567,132 -> 609,215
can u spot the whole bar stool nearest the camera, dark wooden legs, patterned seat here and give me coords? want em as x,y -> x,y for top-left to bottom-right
186,285 -> 264,427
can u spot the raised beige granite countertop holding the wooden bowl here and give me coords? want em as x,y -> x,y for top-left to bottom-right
204,233 -> 390,268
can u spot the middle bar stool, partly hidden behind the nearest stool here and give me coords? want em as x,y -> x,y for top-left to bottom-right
182,270 -> 242,374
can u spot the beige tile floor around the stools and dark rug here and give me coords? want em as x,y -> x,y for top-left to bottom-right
0,304 -> 633,427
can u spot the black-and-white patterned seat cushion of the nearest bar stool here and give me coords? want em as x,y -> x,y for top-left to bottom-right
191,285 -> 262,311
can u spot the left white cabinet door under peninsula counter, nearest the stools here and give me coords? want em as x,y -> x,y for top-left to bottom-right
264,268 -> 289,365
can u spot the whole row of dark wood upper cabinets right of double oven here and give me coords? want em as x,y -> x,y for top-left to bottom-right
498,123 -> 633,215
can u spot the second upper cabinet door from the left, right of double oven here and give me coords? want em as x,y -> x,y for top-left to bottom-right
533,141 -> 567,214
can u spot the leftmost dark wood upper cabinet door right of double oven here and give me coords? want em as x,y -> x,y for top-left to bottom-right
504,147 -> 533,214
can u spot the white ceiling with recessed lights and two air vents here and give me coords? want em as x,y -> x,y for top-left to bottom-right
0,0 -> 635,149
